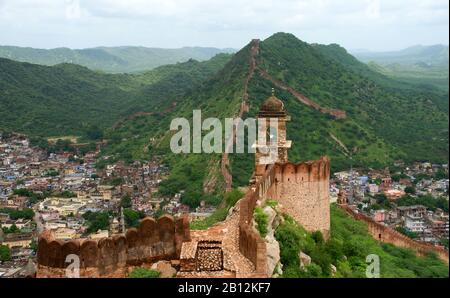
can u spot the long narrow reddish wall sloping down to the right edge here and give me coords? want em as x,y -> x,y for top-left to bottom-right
338,205 -> 449,264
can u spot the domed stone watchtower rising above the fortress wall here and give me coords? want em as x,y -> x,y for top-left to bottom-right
255,88 -> 292,177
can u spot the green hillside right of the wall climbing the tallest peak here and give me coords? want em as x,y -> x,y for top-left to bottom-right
231,33 -> 448,186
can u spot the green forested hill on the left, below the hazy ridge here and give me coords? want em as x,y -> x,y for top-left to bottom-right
0,54 -> 229,137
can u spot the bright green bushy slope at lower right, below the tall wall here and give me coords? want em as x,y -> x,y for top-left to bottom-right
275,205 -> 449,278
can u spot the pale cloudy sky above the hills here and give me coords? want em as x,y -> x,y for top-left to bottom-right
0,0 -> 449,50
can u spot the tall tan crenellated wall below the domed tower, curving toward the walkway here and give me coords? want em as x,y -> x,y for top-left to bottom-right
239,156 -> 330,276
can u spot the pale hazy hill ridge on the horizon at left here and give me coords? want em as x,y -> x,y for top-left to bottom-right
0,46 -> 234,73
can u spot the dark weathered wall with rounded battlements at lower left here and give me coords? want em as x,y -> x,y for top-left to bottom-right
37,215 -> 190,277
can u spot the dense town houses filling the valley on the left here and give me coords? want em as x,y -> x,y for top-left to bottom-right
0,133 -> 192,277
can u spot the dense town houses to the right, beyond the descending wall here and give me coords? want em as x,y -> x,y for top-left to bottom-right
330,162 -> 449,249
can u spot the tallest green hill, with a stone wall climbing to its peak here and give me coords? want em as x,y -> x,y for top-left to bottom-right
99,33 -> 448,205
